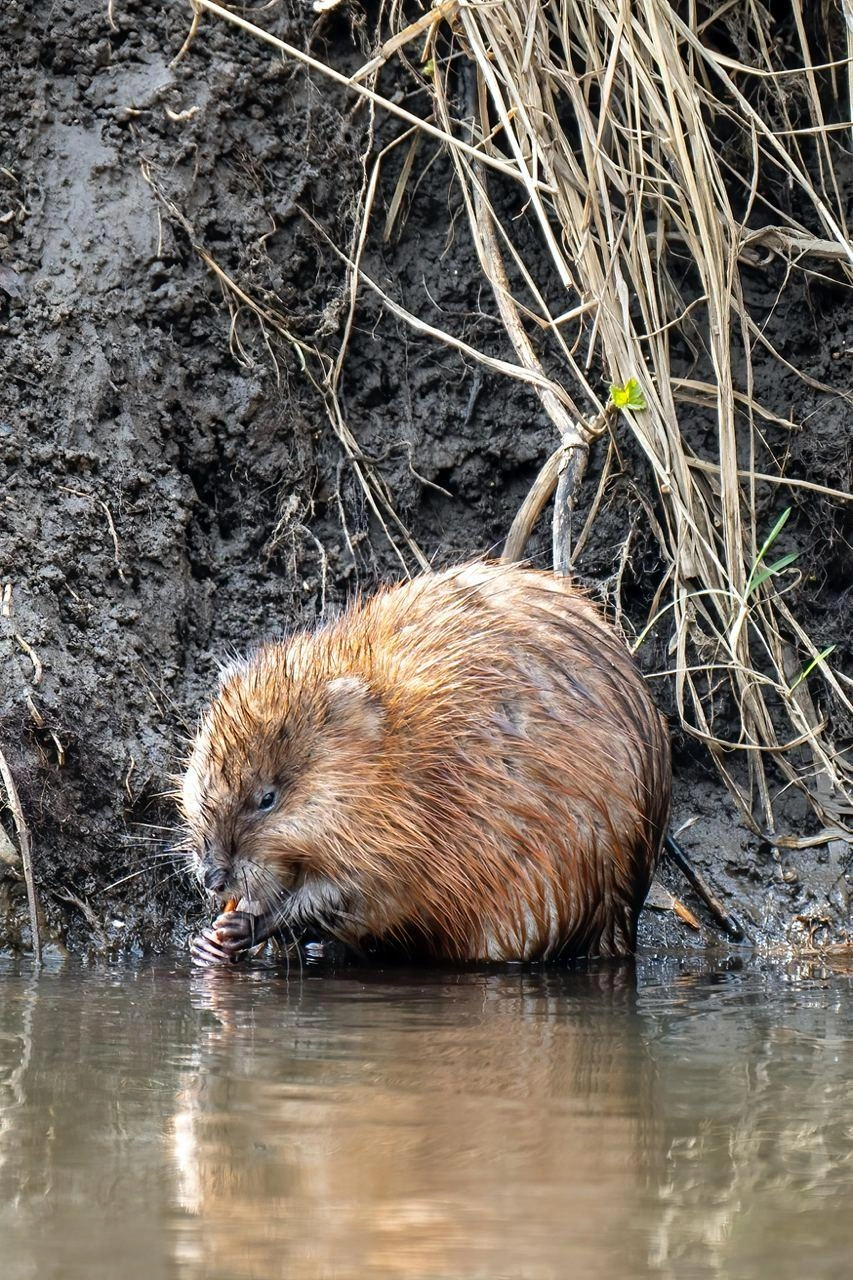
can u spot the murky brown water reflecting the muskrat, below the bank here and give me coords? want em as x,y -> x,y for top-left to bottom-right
0,960 -> 853,1280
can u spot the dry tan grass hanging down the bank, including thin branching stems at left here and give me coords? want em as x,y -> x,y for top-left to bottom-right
174,0 -> 853,838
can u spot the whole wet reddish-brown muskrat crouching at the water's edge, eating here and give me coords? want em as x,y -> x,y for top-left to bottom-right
182,562 -> 671,963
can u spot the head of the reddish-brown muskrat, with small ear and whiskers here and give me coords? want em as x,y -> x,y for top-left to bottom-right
182,645 -> 384,915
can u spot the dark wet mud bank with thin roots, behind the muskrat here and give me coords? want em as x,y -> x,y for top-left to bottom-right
0,0 -> 853,950
